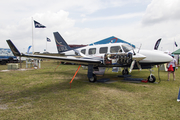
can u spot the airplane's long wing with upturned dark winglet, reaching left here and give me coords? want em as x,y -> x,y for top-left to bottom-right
6,40 -> 102,65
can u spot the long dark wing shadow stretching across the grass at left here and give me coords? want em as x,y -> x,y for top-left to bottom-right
0,80 -> 90,103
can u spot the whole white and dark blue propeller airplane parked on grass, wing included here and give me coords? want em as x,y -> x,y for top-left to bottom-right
7,32 -> 172,82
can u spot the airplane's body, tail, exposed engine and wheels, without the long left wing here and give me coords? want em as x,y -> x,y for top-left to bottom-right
54,32 -> 172,82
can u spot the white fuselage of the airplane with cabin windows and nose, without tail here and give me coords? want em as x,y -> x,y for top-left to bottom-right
64,43 -> 172,64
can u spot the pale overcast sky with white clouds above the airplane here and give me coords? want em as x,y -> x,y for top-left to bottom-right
0,0 -> 180,53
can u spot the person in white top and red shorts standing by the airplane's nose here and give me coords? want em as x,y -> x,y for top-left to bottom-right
167,54 -> 178,81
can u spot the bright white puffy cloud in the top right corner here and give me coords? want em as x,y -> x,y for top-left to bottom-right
143,0 -> 180,24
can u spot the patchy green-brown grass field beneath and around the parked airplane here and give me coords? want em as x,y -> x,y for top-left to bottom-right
0,61 -> 180,120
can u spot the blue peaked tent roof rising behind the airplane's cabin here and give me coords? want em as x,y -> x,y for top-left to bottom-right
89,36 -> 135,48
